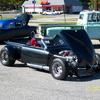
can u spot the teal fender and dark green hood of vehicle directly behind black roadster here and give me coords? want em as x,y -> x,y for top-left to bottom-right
37,24 -> 83,38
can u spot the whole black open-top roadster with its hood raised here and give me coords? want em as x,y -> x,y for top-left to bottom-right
0,30 -> 99,80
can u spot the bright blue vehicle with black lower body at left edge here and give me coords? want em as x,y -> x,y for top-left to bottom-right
0,14 -> 37,42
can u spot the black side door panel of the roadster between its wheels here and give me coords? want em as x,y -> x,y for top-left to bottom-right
21,47 -> 49,65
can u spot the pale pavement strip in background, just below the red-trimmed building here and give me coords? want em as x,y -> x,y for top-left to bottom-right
29,14 -> 78,24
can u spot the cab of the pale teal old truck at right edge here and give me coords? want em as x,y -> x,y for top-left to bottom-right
77,10 -> 100,40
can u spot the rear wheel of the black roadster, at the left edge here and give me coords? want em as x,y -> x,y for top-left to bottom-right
0,47 -> 15,66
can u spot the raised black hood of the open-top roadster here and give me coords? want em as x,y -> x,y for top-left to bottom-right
60,30 -> 95,64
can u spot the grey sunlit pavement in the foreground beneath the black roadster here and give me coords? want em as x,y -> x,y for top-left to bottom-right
0,43 -> 100,100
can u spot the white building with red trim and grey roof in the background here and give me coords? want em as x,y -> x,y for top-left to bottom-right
22,0 -> 82,13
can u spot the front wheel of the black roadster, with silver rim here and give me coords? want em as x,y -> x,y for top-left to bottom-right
50,59 -> 67,80
